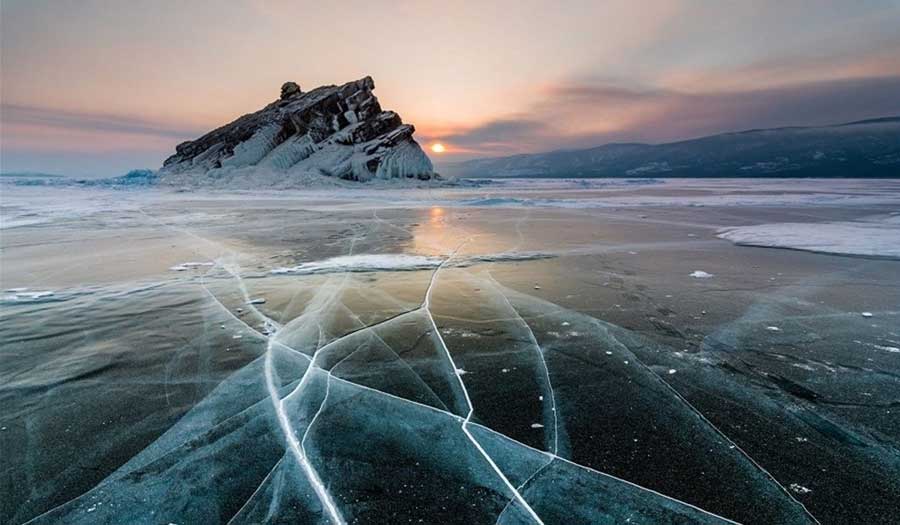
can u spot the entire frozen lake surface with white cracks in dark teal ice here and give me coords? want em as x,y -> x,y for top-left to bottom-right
0,180 -> 900,524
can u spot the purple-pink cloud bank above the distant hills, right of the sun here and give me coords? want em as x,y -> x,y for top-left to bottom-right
428,75 -> 900,160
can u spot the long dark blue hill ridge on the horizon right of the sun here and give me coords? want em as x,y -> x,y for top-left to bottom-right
441,117 -> 900,178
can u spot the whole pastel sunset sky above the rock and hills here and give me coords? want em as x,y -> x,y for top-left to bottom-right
0,0 -> 900,177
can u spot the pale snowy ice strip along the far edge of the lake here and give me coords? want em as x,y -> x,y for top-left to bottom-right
0,179 -> 900,229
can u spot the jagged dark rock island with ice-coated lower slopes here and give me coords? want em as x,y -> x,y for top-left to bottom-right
160,77 -> 434,183
